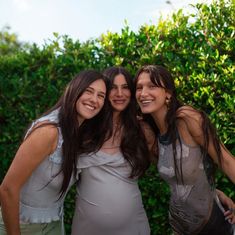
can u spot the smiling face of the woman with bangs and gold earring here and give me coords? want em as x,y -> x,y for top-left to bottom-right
136,72 -> 171,115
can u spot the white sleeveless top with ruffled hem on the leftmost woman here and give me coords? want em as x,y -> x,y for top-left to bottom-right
20,109 -> 75,223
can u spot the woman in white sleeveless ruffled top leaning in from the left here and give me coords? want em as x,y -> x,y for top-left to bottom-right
0,70 -> 106,235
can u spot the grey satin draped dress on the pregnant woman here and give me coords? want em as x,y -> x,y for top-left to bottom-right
72,151 -> 150,235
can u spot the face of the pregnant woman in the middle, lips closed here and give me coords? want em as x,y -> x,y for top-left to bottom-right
109,74 -> 131,112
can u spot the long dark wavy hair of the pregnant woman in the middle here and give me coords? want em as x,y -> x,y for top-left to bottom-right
103,66 -> 149,177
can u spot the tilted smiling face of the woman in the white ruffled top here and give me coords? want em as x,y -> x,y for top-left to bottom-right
76,79 -> 106,124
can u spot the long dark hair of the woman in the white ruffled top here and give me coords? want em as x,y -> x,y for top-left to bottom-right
29,70 -> 106,197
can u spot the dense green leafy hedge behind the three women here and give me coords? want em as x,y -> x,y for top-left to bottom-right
0,0 -> 235,235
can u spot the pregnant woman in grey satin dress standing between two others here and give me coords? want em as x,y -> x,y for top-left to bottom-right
72,67 -> 150,235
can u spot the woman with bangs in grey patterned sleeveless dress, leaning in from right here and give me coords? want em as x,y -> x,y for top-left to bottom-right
136,65 -> 235,235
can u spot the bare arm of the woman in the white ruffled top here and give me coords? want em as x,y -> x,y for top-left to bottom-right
0,125 -> 58,235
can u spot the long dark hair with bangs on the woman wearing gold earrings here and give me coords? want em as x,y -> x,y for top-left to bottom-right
135,65 -> 221,183
